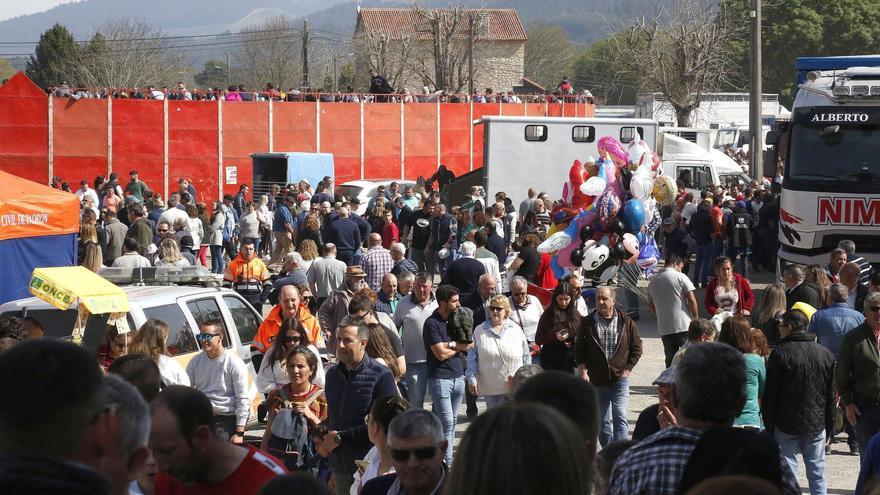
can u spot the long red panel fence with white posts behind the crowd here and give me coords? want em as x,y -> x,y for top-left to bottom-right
0,74 -> 594,201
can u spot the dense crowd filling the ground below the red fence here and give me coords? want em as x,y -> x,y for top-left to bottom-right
0,167 -> 880,495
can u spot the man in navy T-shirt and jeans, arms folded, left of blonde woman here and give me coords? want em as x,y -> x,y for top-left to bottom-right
422,285 -> 474,466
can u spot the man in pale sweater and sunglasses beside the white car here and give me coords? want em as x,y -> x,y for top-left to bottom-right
186,320 -> 251,444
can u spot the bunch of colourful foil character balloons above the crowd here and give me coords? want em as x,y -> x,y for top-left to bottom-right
538,136 -> 678,283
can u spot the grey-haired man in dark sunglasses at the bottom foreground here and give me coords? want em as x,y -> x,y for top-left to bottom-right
361,409 -> 449,495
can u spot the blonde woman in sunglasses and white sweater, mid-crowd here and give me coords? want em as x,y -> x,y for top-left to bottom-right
466,295 -> 532,408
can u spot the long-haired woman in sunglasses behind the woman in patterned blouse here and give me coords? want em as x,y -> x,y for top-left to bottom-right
257,317 -> 324,394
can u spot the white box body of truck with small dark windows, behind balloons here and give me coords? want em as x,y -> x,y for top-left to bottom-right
447,116 -> 657,205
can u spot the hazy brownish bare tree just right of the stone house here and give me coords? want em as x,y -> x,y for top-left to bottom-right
524,21 -> 577,88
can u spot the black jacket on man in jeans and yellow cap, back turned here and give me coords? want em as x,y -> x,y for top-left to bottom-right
763,333 -> 835,435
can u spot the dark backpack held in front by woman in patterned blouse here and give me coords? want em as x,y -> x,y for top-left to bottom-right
268,387 -> 321,474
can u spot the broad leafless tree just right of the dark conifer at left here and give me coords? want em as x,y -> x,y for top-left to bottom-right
76,19 -> 181,88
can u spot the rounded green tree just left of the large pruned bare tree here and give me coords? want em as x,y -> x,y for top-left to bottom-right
569,34 -> 639,105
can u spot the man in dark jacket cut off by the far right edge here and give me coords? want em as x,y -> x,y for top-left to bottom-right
834,292 -> 880,455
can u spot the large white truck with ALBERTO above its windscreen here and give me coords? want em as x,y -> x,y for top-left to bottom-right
764,56 -> 880,274
